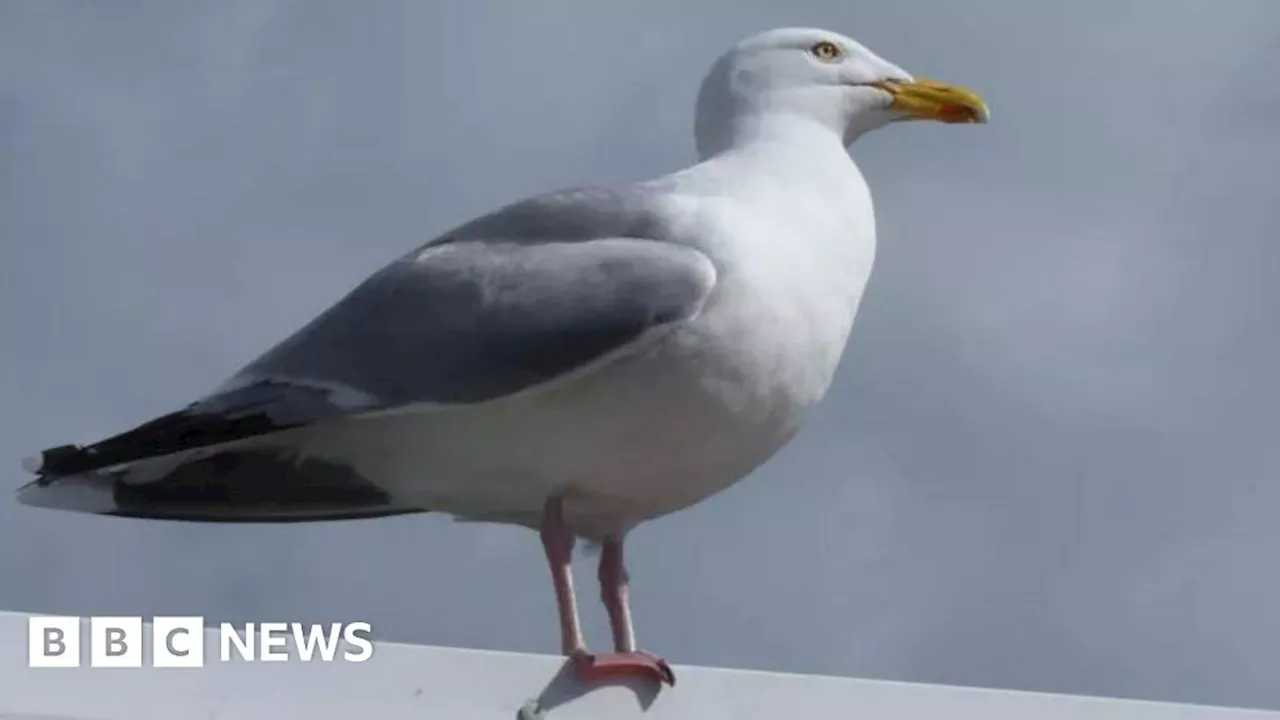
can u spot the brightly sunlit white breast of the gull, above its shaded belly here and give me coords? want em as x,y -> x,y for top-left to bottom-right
670,140 -> 876,413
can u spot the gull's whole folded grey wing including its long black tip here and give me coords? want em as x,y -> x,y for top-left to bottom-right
32,237 -> 716,477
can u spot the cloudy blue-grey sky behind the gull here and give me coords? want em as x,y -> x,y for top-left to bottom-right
0,0 -> 1280,708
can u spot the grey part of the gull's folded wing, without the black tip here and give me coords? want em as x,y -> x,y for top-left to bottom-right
241,238 -> 716,407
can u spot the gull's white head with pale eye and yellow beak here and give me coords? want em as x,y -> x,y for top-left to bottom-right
695,28 -> 988,156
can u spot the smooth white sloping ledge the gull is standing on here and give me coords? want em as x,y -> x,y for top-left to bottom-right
0,604 -> 1280,720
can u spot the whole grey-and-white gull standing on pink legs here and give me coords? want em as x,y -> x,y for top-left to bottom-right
18,28 -> 988,684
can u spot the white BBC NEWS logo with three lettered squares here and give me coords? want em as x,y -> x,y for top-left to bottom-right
27,616 -> 374,667
